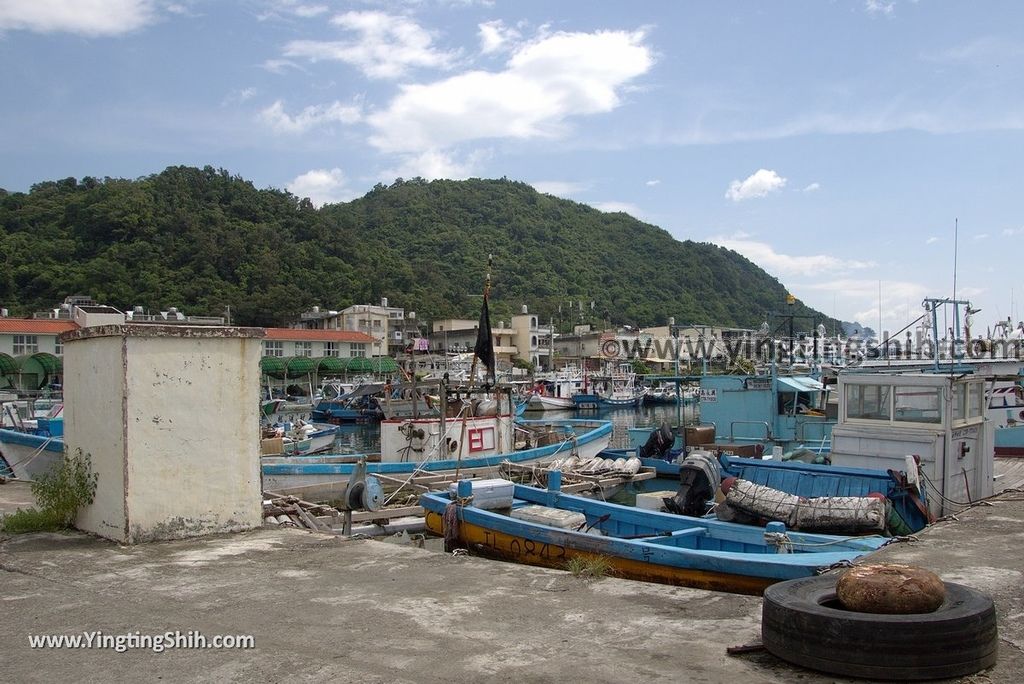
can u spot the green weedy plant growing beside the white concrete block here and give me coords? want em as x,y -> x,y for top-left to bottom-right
2,450 -> 98,533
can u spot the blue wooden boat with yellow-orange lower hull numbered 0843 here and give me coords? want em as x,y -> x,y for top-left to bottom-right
420,476 -> 887,594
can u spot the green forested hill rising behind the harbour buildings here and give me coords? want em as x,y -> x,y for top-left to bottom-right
0,167 -> 831,327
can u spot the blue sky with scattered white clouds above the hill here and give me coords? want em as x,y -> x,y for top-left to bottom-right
0,0 -> 1024,331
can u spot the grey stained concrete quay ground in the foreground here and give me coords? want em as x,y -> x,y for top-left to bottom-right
0,485 -> 1024,684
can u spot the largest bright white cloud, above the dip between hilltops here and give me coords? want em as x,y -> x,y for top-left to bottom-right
368,31 -> 653,153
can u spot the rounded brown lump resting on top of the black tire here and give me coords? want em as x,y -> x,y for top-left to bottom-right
836,563 -> 946,615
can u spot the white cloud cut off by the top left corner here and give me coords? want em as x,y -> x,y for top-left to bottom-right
0,0 -> 157,37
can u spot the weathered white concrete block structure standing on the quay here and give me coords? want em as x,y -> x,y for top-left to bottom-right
65,326 -> 262,544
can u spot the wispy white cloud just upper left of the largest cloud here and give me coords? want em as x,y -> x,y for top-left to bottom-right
285,11 -> 457,79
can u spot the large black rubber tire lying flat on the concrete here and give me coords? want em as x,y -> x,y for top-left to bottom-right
761,575 -> 998,680
